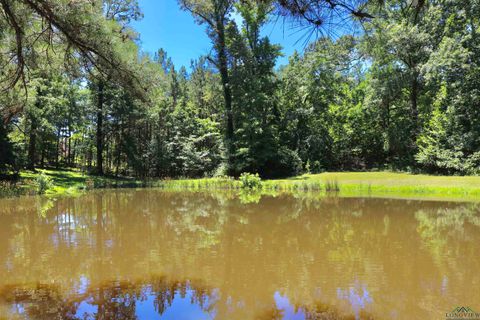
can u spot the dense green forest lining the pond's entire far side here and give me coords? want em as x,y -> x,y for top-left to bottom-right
0,0 -> 480,178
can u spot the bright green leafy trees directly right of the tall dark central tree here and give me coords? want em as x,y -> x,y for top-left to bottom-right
280,36 -> 383,173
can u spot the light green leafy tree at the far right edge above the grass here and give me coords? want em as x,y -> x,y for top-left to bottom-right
416,2 -> 480,174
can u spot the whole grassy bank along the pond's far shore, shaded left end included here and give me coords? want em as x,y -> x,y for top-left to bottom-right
0,170 -> 480,200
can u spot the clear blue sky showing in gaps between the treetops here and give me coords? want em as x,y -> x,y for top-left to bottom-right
133,0 -> 312,67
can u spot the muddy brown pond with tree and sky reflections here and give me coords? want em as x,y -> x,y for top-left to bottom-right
0,189 -> 480,319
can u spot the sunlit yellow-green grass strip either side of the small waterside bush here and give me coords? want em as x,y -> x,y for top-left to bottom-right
157,172 -> 480,200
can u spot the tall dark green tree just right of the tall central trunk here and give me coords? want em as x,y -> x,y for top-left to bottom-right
227,1 -> 301,177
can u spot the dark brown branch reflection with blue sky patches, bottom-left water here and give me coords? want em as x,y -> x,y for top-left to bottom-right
0,278 -> 216,320
